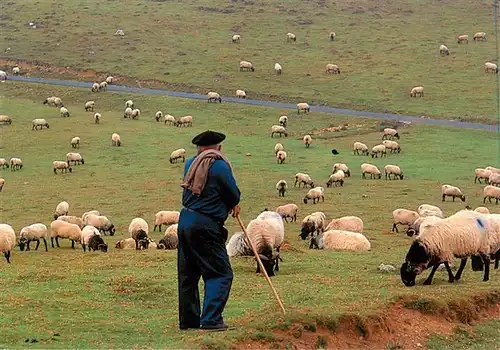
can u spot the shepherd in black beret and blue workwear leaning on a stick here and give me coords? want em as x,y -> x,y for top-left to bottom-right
177,131 -> 240,330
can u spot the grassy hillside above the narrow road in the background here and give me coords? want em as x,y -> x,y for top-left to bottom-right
0,0 -> 496,122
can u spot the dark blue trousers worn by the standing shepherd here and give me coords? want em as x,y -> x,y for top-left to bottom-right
177,209 -> 233,329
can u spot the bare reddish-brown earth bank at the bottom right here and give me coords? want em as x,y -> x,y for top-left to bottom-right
231,290 -> 500,350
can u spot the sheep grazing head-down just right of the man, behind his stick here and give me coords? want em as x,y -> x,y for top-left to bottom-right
247,211 -> 285,277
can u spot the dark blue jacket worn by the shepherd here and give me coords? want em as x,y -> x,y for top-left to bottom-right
182,157 -> 241,223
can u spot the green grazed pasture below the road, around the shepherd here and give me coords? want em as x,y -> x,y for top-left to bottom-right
0,82 -> 500,348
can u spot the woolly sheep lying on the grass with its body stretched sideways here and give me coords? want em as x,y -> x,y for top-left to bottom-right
311,230 -> 371,252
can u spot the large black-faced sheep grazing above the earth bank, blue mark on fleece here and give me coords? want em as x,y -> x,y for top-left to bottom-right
400,211 -> 490,287
